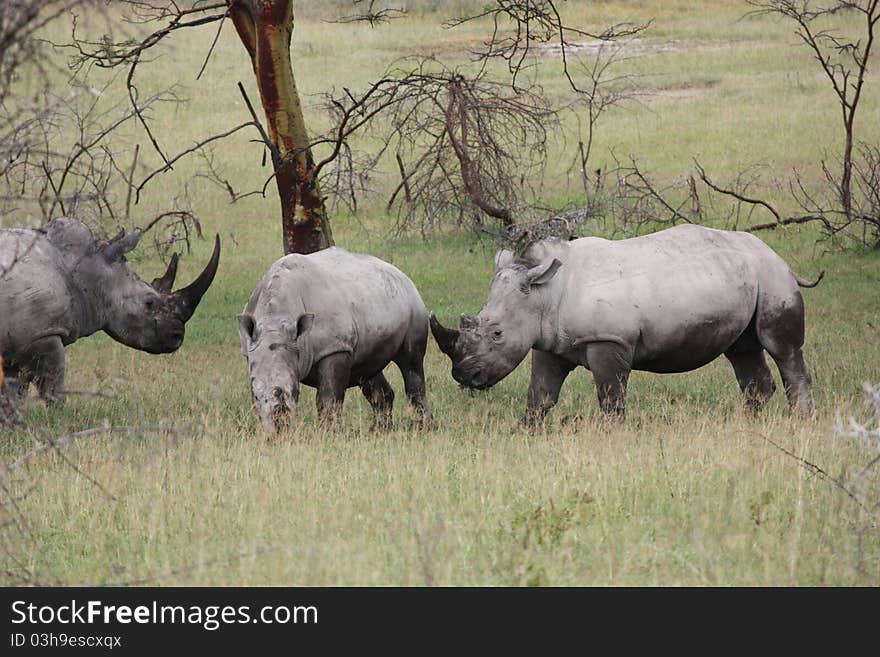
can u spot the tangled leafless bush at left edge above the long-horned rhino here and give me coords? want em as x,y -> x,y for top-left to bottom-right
0,0 -> 210,260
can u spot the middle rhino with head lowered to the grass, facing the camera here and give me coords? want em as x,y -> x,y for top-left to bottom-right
238,247 -> 431,431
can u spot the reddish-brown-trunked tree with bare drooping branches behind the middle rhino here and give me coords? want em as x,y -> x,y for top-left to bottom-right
56,0 -> 646,252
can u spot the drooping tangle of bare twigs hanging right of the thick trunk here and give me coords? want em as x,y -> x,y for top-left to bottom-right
316,58 -> 557,234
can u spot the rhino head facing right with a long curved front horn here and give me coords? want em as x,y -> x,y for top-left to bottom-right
48,220 -> 220,354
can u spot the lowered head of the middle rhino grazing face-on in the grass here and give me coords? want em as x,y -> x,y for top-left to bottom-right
238,313 -> 315,432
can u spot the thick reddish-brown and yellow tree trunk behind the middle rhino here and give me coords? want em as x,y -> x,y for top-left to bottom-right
227,0 -> 333,254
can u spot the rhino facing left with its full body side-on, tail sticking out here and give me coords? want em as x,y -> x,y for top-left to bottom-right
431,225 -> 824,424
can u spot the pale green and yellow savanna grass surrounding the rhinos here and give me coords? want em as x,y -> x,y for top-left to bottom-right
0,0 -> 880,586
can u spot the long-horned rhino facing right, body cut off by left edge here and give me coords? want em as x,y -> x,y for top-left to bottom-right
0,218 -> 220,401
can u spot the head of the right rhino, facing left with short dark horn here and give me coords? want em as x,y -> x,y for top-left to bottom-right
430,251 -> 562,389
